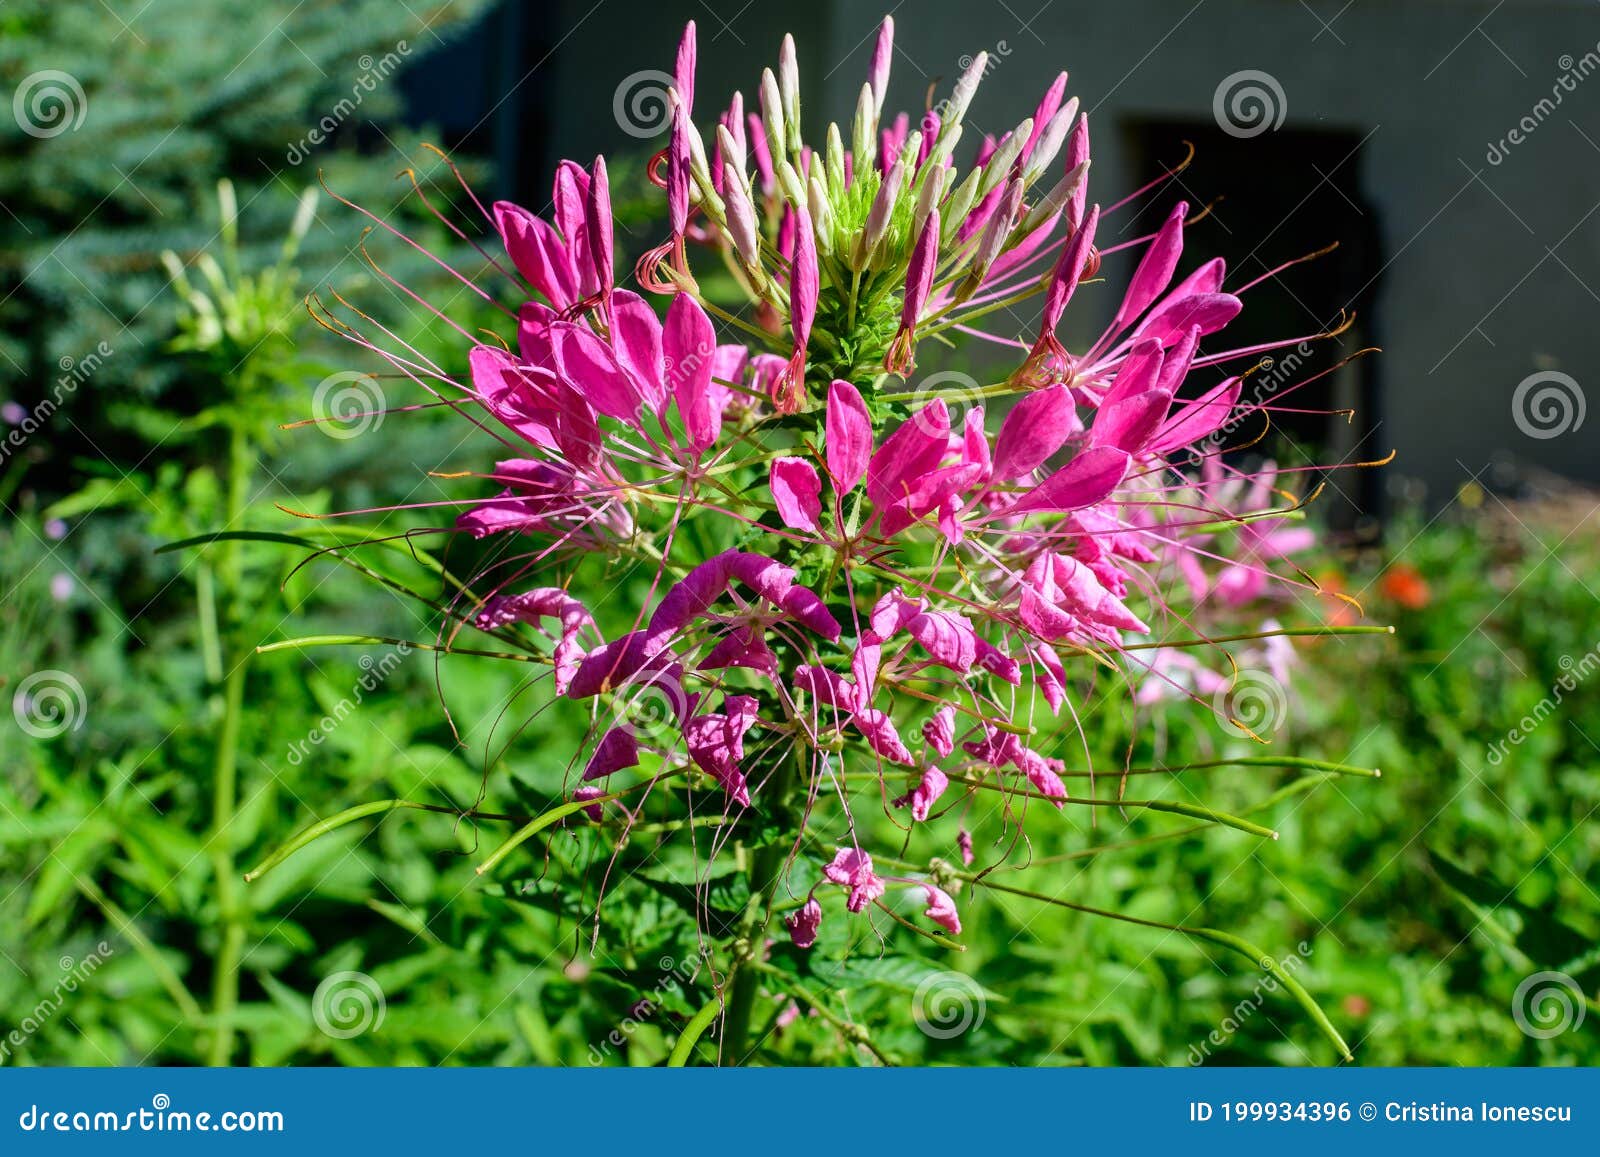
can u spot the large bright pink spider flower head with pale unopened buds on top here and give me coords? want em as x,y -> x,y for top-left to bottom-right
328,19 -> 1350,947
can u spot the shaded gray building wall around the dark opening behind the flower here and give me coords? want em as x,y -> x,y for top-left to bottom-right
531,0 -> 1600,502
